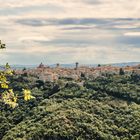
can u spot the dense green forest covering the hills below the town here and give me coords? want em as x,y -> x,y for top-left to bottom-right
0,73 -> 140,140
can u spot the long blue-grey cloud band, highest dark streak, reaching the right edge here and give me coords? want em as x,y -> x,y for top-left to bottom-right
15,18 -> 140,30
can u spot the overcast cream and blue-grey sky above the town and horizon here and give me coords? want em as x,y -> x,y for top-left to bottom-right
0,0 -> 140,64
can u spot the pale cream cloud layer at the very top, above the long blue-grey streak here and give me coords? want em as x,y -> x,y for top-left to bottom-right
0,0 -> 140,18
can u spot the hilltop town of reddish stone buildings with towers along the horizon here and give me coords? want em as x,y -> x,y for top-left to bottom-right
15,62 -> 140,81
